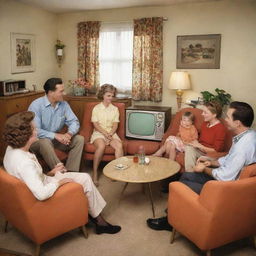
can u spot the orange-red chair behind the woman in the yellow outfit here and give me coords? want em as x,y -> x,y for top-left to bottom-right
80,102 -> 125,161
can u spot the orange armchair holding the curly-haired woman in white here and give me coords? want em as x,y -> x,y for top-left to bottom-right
0,169 -> 88,255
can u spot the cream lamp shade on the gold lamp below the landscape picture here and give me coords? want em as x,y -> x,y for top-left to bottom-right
169,71 -> 190,90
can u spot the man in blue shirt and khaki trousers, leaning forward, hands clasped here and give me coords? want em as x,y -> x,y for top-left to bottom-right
28,78 -> 84,172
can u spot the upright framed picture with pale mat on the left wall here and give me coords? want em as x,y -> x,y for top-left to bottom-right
11,33 -> 35,73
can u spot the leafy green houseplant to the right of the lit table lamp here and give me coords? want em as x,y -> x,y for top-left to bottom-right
201,88 -> 231,107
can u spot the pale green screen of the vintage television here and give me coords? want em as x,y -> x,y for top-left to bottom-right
128,112 -> 155,136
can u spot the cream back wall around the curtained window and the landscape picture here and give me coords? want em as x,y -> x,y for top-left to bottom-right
58,0 -> 256,123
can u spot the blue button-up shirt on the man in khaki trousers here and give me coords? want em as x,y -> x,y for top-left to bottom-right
28,95 -> 80,140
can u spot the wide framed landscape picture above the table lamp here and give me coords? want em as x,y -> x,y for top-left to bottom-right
176,34 -> 221,69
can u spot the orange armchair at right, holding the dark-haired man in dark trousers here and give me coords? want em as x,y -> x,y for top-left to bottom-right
168,164 -> 256,255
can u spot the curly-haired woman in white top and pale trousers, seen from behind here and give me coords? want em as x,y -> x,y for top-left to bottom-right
3,111 -> 121,234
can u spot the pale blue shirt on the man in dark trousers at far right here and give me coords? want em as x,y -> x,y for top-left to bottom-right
212,129 -> 256,181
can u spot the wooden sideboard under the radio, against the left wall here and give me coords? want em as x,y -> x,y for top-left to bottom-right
0,91 -> 44,161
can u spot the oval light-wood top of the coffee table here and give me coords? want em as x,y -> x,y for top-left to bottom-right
103,156 -> 180,183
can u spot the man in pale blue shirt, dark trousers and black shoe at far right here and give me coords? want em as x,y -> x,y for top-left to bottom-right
147,101 -> 256,231
